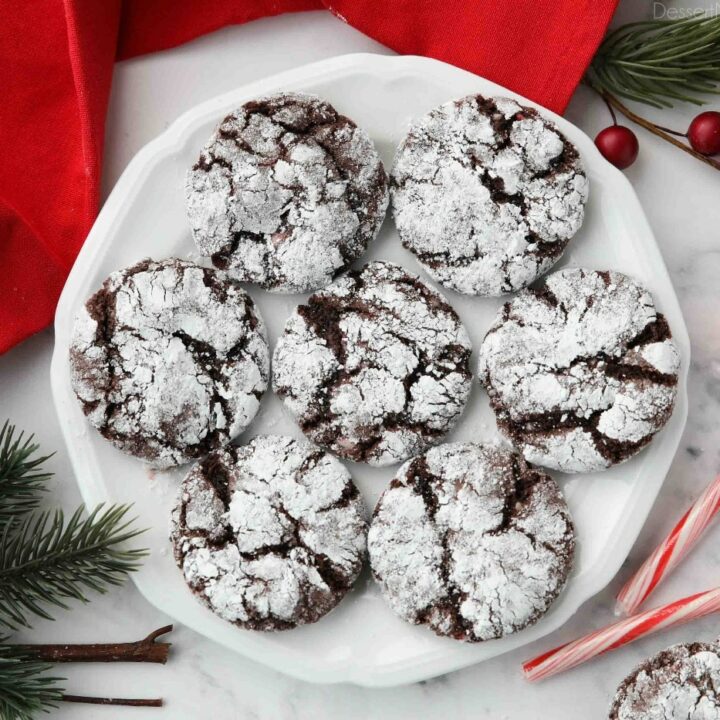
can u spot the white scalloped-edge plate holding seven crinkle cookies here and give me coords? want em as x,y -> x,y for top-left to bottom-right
52,55 -> 690,686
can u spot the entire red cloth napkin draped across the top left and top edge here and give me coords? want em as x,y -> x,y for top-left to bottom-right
0,0 -> 617,353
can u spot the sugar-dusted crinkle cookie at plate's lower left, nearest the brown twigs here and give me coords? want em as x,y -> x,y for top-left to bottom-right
172,435 -> 367,630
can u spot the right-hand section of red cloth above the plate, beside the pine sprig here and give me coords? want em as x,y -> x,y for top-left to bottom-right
325,0 -> 617,122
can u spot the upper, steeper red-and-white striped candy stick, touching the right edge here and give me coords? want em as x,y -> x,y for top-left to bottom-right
617,475 -> 720,615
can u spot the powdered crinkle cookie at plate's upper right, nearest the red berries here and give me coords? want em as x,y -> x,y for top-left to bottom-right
390,95 -> 588,295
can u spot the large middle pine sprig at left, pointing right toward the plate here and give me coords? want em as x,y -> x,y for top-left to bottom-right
0,505 -> 147,629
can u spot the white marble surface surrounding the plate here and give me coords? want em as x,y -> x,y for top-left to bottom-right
0,0 -> 720,720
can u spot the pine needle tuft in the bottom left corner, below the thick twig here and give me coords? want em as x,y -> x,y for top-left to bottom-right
0,645 -> 64,720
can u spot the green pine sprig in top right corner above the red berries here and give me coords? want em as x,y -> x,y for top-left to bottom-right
585,16 -> 720,108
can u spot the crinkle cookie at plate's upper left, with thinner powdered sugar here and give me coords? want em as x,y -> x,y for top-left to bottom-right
186,93 -> 388,292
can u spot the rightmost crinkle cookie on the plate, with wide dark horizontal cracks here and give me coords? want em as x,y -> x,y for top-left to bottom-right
478,268 -> 680,472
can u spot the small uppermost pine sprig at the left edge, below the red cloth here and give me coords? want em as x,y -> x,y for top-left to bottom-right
0,420 -> 52,532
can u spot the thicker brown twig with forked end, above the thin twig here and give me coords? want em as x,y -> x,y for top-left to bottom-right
12,625 -> 173,664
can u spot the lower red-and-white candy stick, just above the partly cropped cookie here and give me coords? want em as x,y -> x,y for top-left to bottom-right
523,588 -> 720,681
